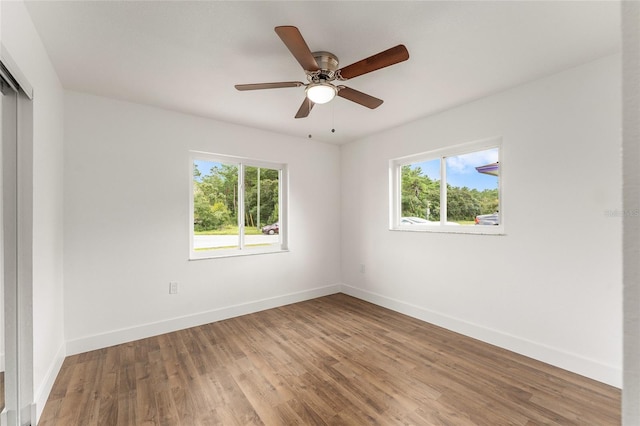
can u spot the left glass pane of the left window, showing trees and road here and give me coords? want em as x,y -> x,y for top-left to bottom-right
193,160 -> 240,251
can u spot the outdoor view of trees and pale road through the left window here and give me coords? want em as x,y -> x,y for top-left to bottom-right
193,160 -> 280,251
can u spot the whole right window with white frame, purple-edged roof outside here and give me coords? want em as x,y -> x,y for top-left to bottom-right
390,139 -> 504,234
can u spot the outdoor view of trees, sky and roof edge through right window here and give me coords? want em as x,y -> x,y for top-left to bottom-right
401,148 -> 500,225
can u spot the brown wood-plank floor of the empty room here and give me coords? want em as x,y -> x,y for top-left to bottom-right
39,294 -> 620,426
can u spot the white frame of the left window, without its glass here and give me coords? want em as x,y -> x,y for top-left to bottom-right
188,151 -> 289,260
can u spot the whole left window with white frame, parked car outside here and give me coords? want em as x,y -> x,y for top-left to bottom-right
190,152 -> 287,259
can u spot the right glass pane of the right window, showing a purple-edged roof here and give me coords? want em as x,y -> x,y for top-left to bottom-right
446,148 -> 500,225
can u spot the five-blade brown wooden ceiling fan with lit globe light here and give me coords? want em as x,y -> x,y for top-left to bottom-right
235,25 -> 409,118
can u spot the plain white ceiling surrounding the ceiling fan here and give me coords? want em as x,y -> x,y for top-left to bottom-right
26,0 -> 620,144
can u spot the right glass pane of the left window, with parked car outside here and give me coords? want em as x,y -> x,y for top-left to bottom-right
244,166 -> 280,248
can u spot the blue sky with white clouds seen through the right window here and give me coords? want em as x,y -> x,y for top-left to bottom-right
411,148 -> 498,191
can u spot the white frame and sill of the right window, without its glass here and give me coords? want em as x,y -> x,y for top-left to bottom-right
389,137 -> 505,235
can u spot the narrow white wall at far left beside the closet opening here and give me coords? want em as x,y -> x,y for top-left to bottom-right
1,1 -> 65,420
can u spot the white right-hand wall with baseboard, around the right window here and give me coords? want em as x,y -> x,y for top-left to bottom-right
341,56 -> 622,386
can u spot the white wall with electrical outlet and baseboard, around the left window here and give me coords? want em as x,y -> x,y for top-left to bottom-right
64,92 -> 340,353
